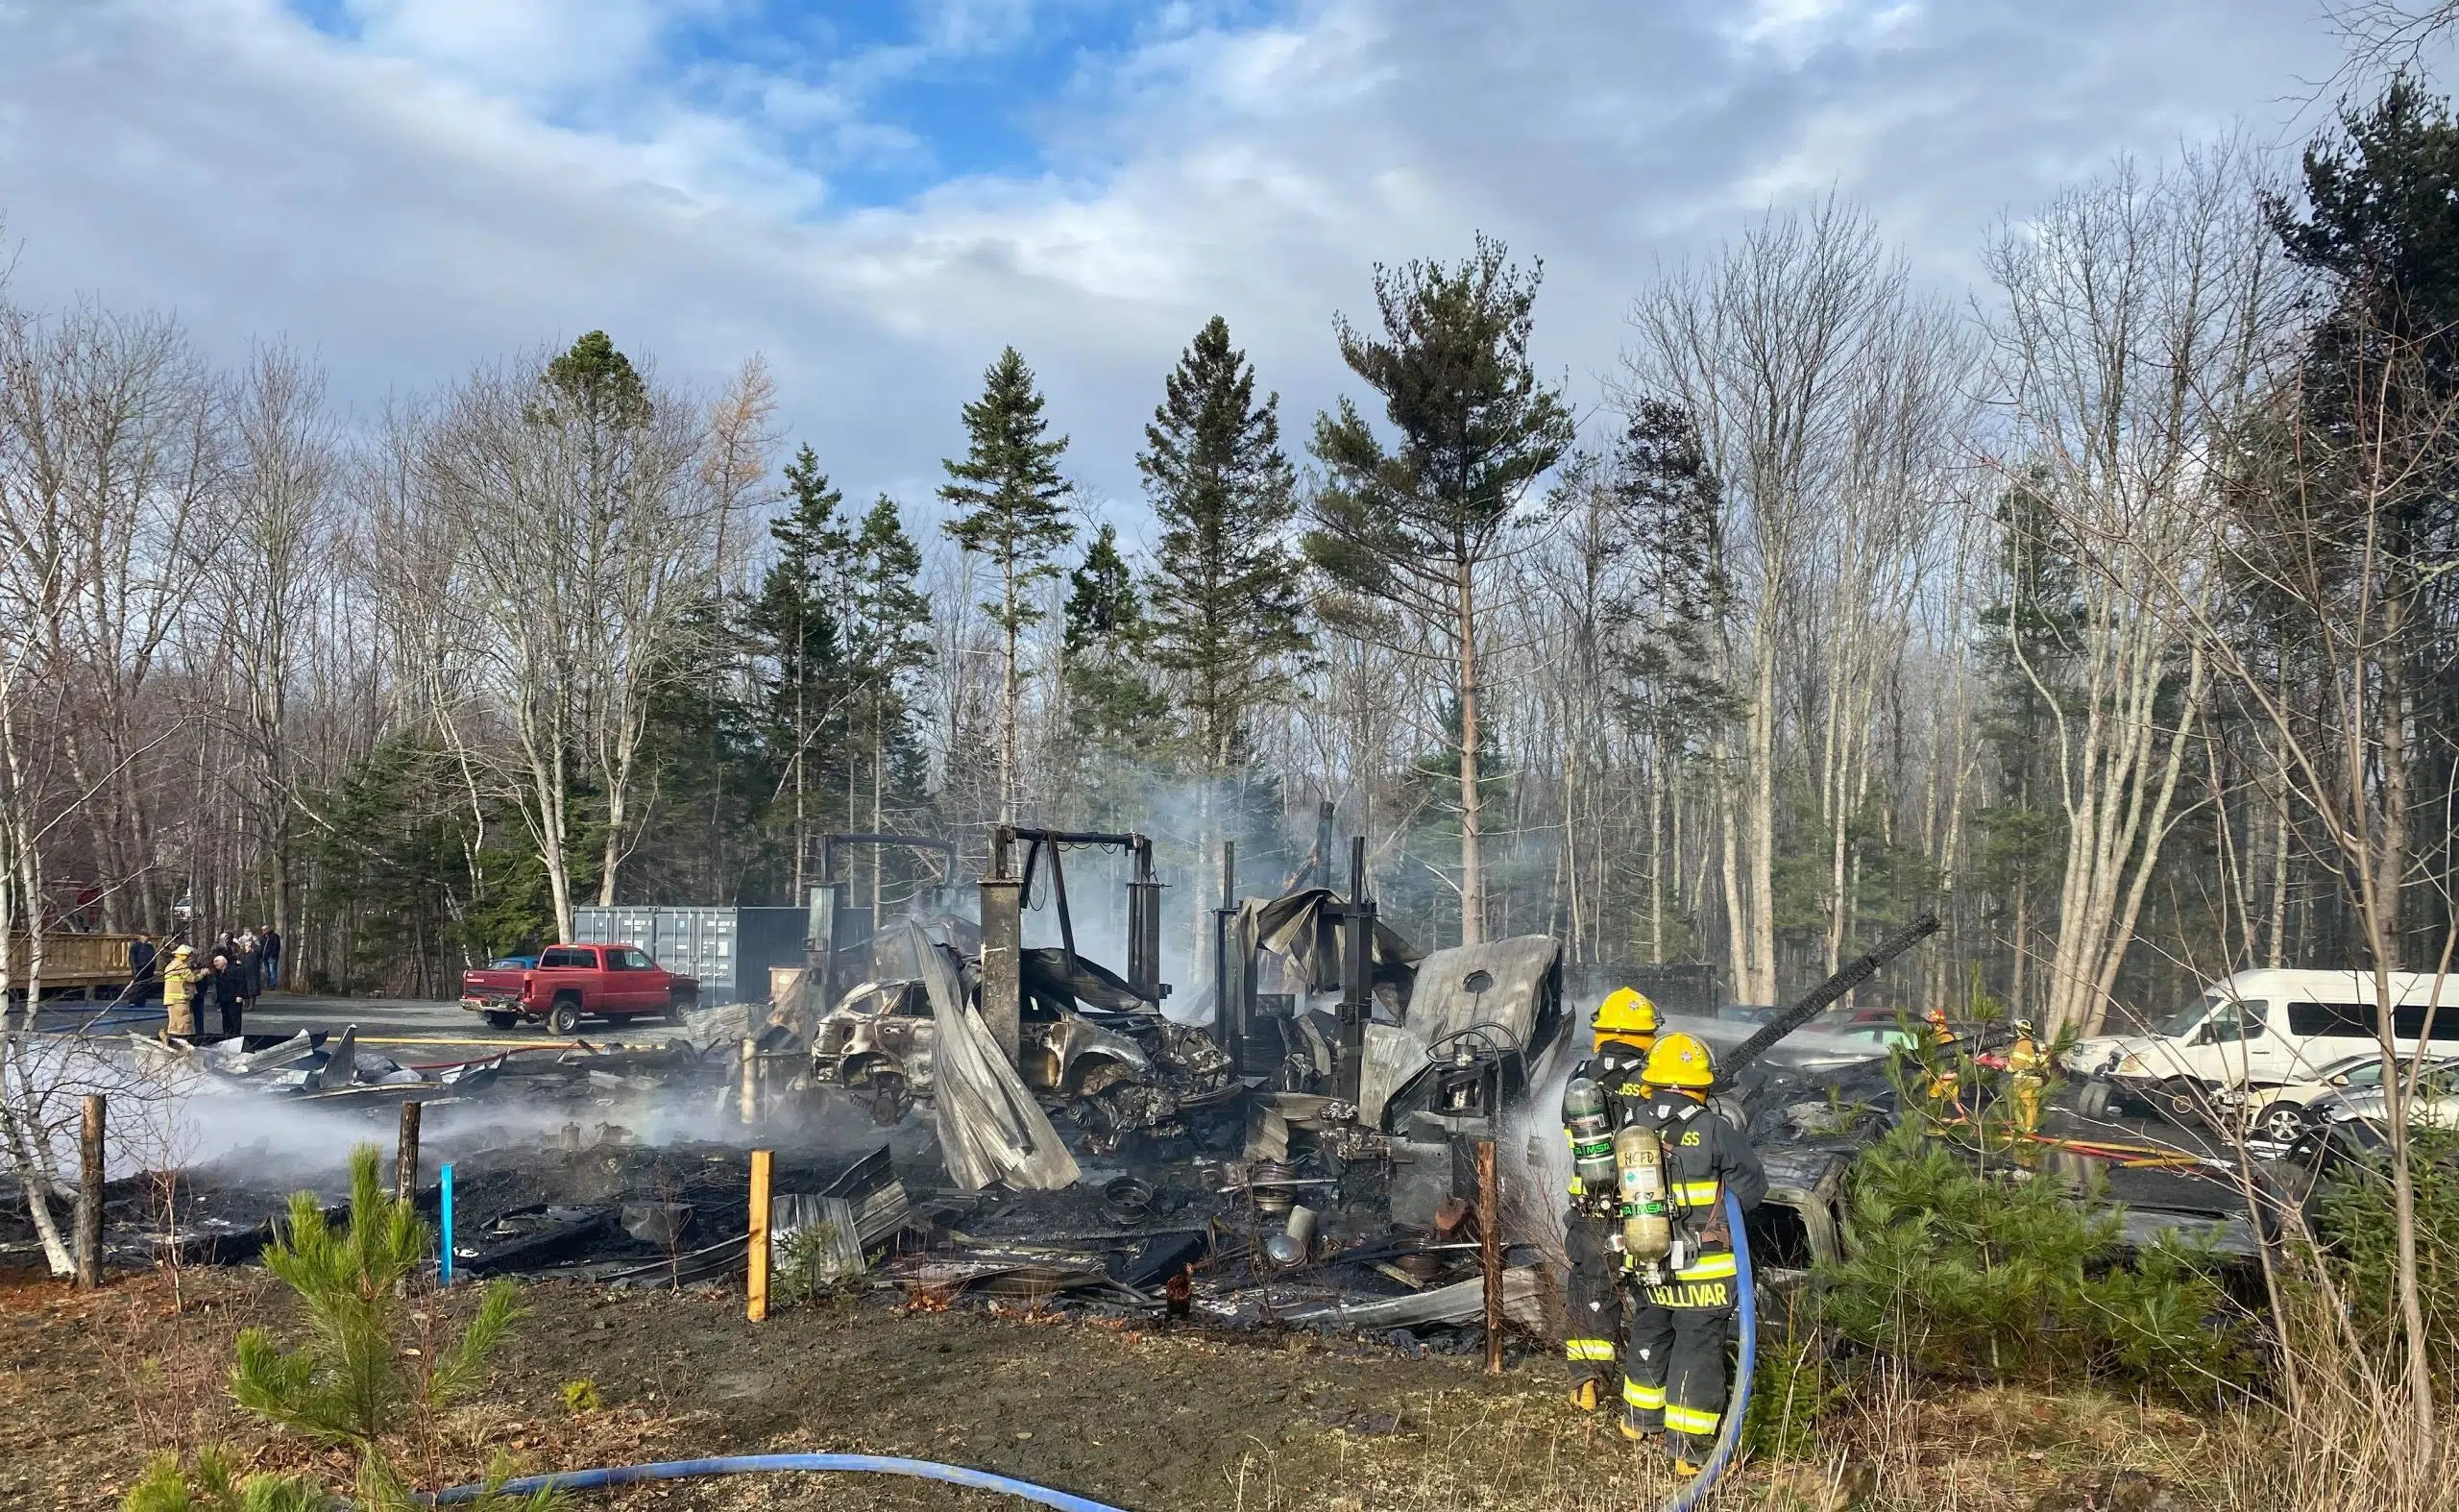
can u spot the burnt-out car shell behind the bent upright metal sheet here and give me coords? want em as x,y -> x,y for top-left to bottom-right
812,922 -> 1242,1151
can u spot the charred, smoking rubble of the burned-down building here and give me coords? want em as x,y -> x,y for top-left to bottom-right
0,829 -> 2250,1377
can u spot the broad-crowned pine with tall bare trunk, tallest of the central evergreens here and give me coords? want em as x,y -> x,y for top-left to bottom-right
1305,236 -> 1576,944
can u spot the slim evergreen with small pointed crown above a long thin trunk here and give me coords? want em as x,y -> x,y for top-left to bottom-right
939,347 -> 1075,823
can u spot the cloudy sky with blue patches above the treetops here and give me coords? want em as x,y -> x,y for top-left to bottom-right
0,0 -> 2380,538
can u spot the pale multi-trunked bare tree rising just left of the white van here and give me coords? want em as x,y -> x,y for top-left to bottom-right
1986,145 -> 2279,1033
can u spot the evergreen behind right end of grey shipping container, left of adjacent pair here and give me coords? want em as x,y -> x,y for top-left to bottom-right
750,448 -> 853,900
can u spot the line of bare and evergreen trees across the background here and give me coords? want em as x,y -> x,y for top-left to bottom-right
0,81 -> 2459,1028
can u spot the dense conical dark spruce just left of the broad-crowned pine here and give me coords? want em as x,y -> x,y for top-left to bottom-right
1136,315 -> 1310,779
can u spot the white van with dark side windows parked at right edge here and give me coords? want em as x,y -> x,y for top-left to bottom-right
2065,971 -> 2459,1113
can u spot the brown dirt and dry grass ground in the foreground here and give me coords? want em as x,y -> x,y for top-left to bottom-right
0,1269 -> 2208,1512
